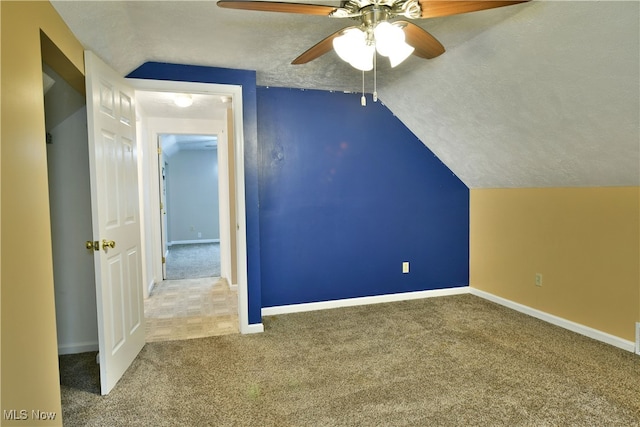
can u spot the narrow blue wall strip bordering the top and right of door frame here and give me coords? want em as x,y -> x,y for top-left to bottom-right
127,62 -> 262,324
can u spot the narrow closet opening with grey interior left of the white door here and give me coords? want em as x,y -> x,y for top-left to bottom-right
43,64 -> 98,355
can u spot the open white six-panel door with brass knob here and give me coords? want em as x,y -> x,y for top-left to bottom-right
85,51 -> 145,394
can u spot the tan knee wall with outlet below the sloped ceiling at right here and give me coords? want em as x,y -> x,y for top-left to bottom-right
470,187 -> 640,341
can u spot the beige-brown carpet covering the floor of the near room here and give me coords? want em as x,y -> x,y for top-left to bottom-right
60,295 -> 640,426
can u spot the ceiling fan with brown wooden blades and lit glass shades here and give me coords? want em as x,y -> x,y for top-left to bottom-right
217,0 -> 529,71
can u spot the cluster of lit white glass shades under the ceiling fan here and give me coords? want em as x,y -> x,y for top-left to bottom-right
333,21 -> 414,71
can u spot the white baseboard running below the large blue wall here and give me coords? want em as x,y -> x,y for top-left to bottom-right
262,286 -> 469,316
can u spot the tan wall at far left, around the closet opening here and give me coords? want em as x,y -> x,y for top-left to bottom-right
0,1 -> 84,426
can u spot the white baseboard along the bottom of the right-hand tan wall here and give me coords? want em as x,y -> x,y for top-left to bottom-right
469,288 -> 635,353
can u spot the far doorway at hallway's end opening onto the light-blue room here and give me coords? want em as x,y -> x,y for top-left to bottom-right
158,134 -> 221,280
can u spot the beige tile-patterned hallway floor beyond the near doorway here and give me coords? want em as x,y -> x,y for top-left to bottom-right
144,277 -> 239,342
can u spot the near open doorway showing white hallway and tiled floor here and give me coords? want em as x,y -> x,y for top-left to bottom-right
136,87 -> 246,341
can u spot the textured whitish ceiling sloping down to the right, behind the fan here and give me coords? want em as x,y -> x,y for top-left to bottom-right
52,0 -> 640,188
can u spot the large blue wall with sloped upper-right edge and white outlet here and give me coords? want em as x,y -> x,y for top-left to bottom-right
257,87 -> 469,307
